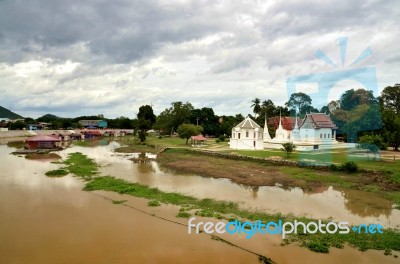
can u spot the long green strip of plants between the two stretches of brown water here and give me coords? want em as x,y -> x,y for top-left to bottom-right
84,176 -> 400,253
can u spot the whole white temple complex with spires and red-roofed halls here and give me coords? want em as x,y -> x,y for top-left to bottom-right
229,113 -> 352,151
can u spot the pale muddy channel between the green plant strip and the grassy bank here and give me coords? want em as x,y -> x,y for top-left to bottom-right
61,142 -> 400,228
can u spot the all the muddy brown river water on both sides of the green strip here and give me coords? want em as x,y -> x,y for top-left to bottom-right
0,142 -> 400,263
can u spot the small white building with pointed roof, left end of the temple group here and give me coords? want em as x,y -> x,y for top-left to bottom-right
229,116 -> 263,149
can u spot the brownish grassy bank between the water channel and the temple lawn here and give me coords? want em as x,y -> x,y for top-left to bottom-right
157,149 -> 400,205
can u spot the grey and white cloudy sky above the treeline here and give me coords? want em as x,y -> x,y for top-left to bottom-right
0,0 -> 400,118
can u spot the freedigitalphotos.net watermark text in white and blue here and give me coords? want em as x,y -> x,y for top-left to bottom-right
188,217 -> 383,239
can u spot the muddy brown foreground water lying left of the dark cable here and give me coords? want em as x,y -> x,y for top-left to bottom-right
0,146 -> 257,263
